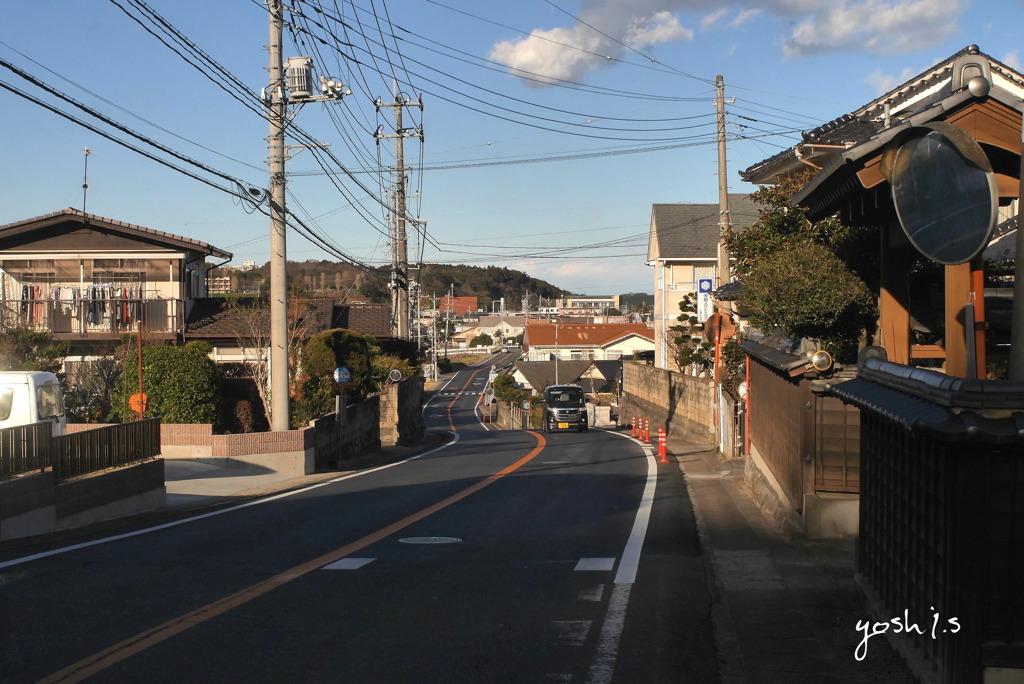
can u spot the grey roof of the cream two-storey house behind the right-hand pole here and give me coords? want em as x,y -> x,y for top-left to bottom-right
647,194 -> 759,261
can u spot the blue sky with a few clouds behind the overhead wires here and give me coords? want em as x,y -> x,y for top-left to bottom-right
0,0 -> 1024,294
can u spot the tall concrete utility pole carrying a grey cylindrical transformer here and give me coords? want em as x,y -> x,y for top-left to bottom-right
262,0 -> 351,432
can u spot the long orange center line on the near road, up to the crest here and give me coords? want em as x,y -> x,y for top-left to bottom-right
41,430 -> 547,682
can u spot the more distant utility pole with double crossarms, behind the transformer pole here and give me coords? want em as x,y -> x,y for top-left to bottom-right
374,88 -> 423,340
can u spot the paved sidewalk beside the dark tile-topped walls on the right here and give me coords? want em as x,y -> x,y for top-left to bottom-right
667,439 -> 918,684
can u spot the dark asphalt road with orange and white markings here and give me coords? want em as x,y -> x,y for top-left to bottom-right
0,366 -> 718,683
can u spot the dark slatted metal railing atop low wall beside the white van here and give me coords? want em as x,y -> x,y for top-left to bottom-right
0,418 -> 161,480
